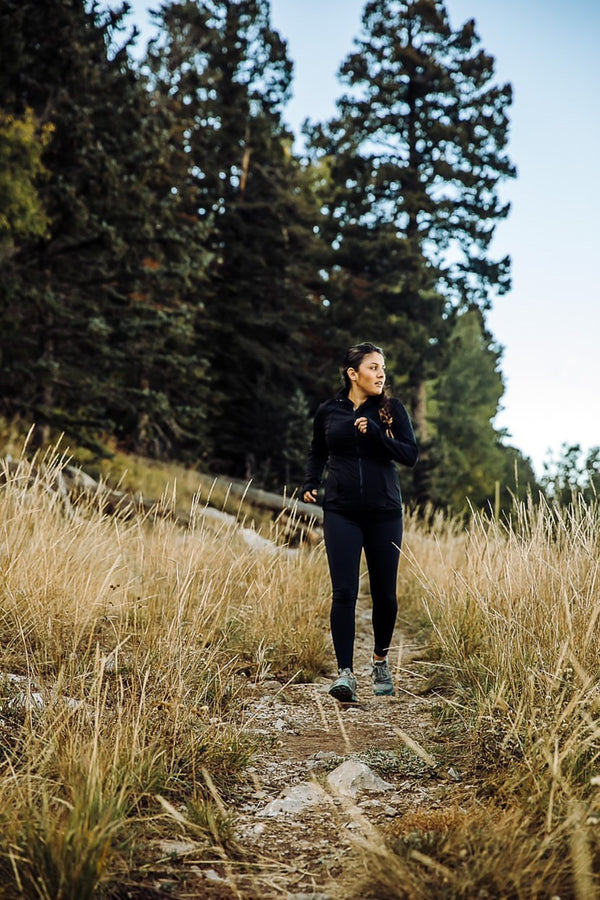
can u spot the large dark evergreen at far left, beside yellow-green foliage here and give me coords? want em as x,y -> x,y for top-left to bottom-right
0,0 -> 211,451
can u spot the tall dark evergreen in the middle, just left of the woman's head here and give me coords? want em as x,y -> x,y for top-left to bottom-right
148,0 -> 328,485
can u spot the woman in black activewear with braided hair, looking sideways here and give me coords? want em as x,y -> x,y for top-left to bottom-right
302,343 -> 418,702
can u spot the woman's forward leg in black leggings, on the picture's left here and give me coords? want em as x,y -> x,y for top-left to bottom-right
323,510 -> 363,669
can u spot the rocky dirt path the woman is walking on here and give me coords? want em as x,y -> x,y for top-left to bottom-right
155,599 -> 469,900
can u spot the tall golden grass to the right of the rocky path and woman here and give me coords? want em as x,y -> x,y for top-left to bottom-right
359,499 -> 600,900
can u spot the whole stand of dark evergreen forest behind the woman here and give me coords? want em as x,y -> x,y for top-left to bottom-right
0,0 -> 600,511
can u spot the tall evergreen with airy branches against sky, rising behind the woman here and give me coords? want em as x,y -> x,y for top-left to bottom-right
310,0 -> 514,499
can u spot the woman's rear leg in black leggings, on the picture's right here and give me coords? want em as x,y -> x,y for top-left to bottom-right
365,513 -> 402,656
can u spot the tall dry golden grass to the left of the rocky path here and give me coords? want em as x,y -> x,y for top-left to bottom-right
0,455 -> 327,900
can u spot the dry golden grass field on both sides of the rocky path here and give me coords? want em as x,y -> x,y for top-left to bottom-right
0,446 -> 600,900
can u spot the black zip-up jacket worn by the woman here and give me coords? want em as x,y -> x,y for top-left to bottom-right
302,390 -> 418,512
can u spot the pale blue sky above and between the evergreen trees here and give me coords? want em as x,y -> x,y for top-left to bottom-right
116,0 -> 600,475
